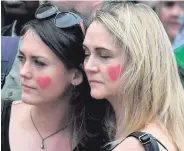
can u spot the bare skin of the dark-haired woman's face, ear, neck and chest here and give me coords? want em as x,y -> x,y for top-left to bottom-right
9,30 -> 82,151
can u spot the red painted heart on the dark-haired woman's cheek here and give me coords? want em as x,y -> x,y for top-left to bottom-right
36,76 -> 52,89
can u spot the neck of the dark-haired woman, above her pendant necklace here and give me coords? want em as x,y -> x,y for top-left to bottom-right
30,97 -> 70,137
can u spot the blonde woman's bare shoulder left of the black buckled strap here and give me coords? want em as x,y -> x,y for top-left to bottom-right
113,137 -> 144,151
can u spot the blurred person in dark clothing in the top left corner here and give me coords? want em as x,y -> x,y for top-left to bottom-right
1,0 -> 39,36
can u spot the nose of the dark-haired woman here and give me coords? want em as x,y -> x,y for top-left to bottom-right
19,62 -> 32,79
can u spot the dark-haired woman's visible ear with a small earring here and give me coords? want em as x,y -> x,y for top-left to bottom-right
71,69 -> 83,86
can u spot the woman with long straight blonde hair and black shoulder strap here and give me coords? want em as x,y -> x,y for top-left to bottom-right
83,1 -> 184,151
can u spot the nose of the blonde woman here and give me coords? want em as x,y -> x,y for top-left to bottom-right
84,57 -> 99,72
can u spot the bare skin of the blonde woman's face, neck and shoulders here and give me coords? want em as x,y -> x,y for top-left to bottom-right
83,21 -> 176,151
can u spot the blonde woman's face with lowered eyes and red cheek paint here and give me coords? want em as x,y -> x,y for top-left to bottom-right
83,22 -> 123,101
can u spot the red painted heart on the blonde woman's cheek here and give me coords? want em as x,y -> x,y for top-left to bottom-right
107,65 -> 121,81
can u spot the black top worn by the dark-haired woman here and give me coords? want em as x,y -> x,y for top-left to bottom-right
1,100 -> 105,151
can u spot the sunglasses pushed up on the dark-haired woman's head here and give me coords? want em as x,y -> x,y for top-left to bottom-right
35,3 -> 84,34
